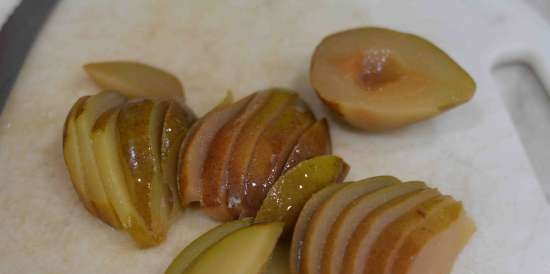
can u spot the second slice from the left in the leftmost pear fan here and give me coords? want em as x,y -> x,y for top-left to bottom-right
76,91 -> 126,228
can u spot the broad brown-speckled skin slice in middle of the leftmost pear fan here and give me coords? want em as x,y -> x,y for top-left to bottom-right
117,98 -> 169,242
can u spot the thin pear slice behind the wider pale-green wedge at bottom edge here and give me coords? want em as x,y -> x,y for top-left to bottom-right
164,218 -> 252,274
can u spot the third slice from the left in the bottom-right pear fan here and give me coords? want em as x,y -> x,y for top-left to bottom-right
320,182 -> 432,274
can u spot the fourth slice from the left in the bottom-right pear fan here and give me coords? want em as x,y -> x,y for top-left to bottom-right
339,185 -> 440,274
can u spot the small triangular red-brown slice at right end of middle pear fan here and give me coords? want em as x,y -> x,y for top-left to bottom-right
283,118 -> 332,173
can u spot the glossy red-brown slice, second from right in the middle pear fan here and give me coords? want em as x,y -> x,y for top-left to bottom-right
241,105 -> 315,216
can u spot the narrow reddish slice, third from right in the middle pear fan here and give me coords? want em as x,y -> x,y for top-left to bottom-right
227,89 -> 298,218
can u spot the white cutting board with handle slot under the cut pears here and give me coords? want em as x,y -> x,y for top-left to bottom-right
0,0 -> 550,274
